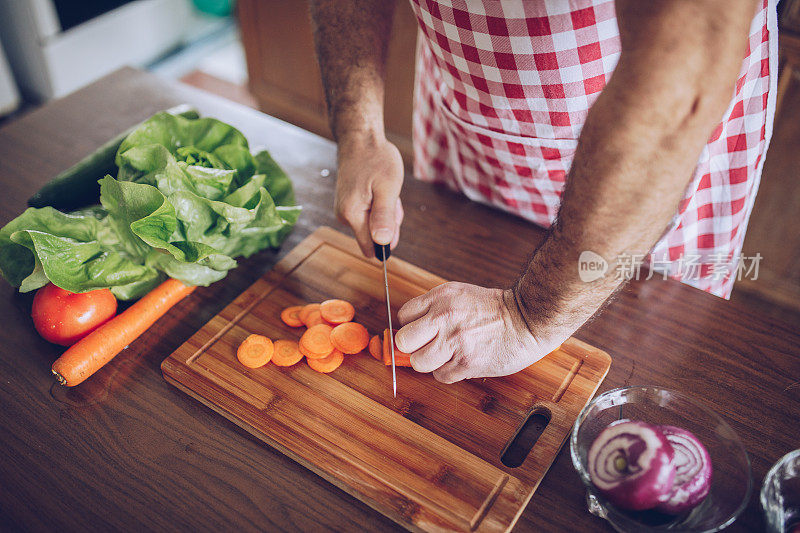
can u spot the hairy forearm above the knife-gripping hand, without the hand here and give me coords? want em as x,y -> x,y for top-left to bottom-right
311,0 -> 395,141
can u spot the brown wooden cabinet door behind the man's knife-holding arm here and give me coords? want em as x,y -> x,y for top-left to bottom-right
238,0 -> 417,163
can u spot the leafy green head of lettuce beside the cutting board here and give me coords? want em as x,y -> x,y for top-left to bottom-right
0,113 -> 300,300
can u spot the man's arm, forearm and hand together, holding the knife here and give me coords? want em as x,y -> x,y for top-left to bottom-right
311,0 -> 403,257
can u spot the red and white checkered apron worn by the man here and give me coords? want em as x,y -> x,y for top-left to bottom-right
411,0 -> 777,298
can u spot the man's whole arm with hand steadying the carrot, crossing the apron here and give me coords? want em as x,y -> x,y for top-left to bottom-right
396,0 -> 756,383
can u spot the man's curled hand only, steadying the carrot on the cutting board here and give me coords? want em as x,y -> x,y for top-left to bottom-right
395,282 -> 569,383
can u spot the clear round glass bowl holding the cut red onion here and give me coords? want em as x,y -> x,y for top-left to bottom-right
570,387 -> 753,532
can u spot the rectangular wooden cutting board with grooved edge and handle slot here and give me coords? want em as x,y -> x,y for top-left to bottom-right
161,228 -> 611,531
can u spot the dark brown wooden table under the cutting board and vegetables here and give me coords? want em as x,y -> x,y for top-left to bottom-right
0,69 -> 800,531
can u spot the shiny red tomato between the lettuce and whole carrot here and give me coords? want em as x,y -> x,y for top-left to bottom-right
31,283 -> 117,346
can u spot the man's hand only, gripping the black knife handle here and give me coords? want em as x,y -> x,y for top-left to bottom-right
335,135 -> 403,257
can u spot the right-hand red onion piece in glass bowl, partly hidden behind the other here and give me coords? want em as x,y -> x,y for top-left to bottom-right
656,426 -> 711,514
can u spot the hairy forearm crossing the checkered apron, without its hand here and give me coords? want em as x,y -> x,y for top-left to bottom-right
515,1 -> 753,334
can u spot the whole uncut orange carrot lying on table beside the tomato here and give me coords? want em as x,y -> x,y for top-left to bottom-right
52,279 -> 195,387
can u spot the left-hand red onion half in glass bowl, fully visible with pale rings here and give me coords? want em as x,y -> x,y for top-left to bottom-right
588,420 -> 675,511
